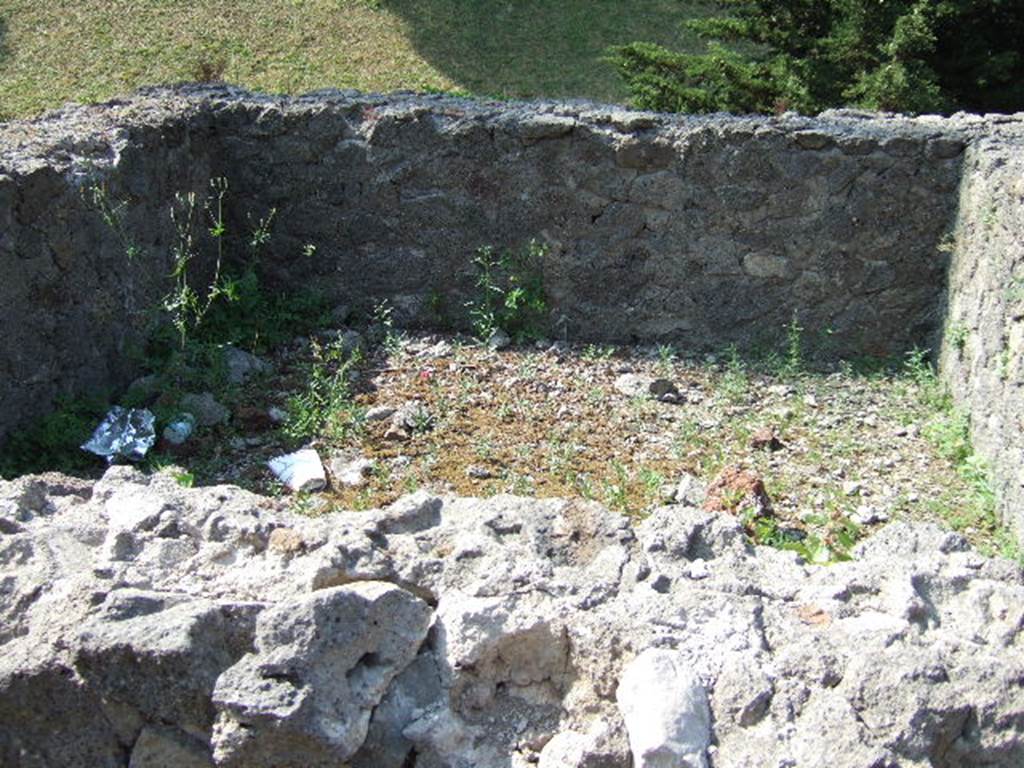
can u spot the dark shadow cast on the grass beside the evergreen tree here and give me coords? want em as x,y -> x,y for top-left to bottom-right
382,0 -> 703,101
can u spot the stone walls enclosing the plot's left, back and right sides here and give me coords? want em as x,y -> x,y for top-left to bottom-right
0,87 -> 1024,532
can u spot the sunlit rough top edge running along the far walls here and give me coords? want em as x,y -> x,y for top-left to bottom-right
0,84 -> 1024,178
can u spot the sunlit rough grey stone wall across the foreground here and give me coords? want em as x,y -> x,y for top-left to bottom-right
0,467 -> 1024,768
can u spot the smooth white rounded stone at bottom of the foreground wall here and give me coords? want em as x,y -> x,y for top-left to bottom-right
615,648 -> 711,768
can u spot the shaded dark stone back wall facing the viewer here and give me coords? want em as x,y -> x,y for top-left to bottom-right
211,93 -> 961,354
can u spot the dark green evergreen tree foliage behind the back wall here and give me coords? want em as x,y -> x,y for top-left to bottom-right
611,0 -> 1024,114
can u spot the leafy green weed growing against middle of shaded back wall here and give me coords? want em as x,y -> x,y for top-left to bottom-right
467,240 -> 548,342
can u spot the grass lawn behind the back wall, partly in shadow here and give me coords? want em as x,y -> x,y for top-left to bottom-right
0,0 -> 700,119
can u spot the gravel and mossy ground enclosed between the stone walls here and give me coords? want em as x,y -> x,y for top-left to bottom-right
165,331 -> 1005,554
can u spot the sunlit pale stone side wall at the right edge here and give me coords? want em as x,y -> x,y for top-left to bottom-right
941,138 -> 1024,532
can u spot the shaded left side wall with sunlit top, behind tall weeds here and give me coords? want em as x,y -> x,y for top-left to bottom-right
0,102 -> 215,440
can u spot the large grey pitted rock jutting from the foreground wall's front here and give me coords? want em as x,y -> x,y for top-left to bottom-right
213,582 -> 430,768
